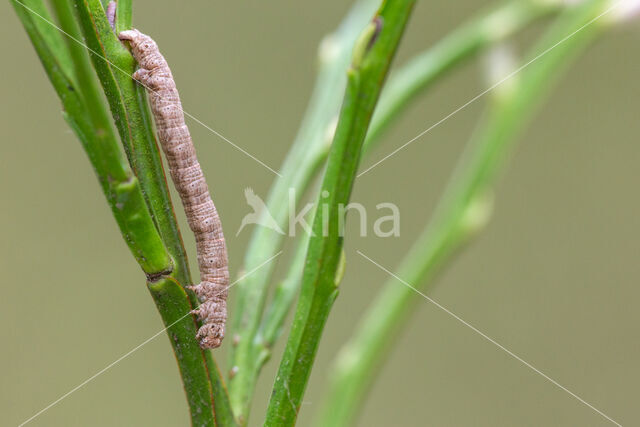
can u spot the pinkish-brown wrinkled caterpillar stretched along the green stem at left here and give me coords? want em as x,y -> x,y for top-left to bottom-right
118,29 -> 229,348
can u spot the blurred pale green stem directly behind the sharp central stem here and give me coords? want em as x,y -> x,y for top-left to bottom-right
229,0 -> 380,422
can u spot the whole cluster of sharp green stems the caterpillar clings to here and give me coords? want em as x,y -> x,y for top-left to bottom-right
14,1 -> 235,426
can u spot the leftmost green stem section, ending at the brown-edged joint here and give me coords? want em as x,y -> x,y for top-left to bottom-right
11,0 -> 171,275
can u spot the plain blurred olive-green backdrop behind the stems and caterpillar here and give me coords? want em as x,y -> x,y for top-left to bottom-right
0,0 -> 640,426
